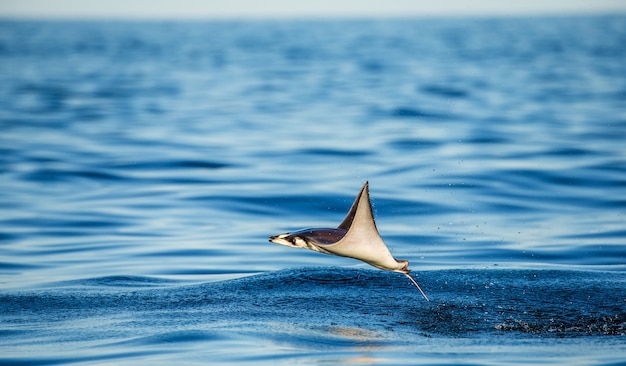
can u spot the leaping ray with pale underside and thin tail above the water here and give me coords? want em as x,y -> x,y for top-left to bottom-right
270,182 -> 429,300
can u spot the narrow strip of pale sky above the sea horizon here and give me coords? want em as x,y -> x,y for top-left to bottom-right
0,0 -> 626,19
